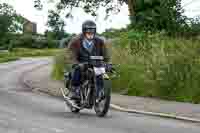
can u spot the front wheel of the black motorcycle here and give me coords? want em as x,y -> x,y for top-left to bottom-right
94,80 -> 111,117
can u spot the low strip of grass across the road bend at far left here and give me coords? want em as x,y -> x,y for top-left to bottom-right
0,48 -> 61,63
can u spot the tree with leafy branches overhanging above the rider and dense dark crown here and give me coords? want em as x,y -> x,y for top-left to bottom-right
38,0 -> 187,33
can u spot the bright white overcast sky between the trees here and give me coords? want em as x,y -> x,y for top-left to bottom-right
0,0 -> 200,33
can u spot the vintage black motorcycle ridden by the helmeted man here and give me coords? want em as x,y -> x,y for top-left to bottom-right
61,56 -> 114,117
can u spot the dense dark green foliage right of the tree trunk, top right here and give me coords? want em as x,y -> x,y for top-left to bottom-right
131,0 -> 186,32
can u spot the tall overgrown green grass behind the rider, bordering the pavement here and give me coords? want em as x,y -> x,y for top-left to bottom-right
52,33 -> 200,103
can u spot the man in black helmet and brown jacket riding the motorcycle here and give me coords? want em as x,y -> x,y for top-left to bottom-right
66,20 -> 110,99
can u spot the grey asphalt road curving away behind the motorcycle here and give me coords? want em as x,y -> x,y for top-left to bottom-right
0,58 -> 200,133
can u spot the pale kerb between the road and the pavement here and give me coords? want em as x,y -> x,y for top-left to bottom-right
21,62 -> 200,123
